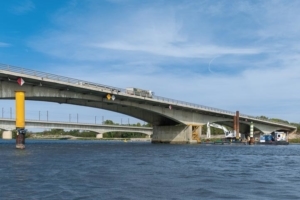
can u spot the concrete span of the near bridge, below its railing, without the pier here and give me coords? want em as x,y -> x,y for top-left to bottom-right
0,72 -> 296,134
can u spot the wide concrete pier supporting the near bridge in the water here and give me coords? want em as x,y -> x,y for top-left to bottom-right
152,125 -> 200,144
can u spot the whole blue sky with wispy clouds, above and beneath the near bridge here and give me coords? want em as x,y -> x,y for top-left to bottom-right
0,0 -> 300,123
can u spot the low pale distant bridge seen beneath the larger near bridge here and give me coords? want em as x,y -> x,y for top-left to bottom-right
0,118 -> 153,137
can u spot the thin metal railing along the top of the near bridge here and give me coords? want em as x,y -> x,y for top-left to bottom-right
0,64 -> 292,127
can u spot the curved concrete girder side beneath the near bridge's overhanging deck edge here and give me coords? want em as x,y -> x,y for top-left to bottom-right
0,81 -> 230,126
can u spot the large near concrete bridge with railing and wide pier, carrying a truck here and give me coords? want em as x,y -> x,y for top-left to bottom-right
0,64 -> 296,143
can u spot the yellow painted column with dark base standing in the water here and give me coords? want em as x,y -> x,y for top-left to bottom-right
15,91 -> 26,149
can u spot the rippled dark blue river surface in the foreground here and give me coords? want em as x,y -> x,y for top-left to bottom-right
0,139 -> 300,200
